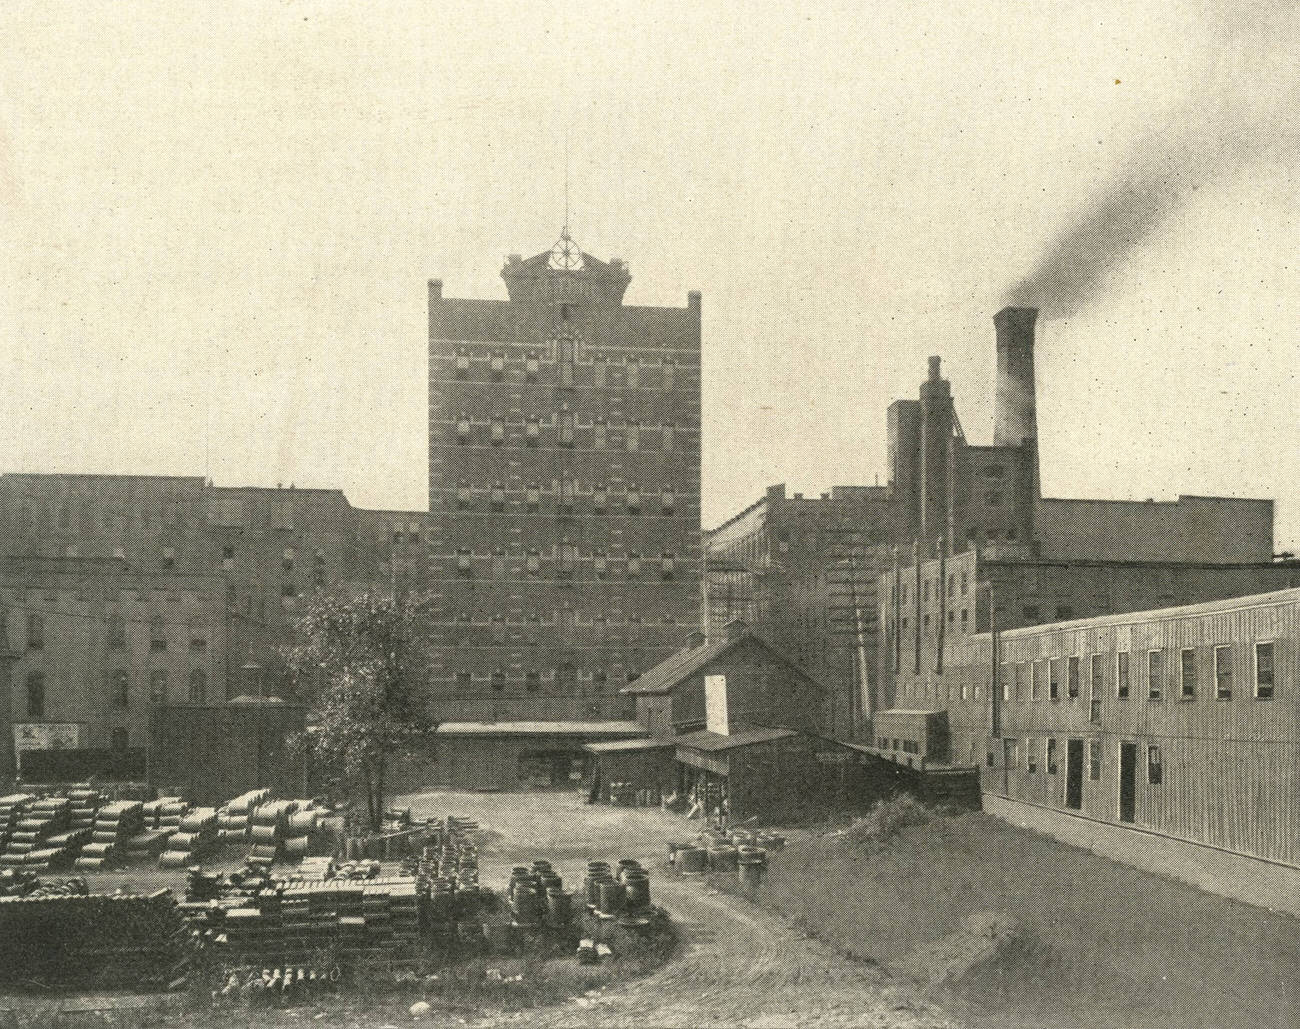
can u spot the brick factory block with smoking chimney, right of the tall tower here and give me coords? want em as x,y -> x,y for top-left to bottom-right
706,308 -> 1273,734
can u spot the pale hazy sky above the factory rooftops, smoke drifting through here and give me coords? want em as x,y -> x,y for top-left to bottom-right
0,0 -> 1300,546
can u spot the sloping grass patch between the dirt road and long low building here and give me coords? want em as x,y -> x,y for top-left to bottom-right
719,798 -> 1300,1028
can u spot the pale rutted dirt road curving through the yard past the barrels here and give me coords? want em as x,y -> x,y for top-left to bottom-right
406,794 -> 957,1029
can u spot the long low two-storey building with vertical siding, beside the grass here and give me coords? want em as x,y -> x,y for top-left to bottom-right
875,589 -> 1300,868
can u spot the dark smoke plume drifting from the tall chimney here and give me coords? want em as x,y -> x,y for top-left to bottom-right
1004,5 -> 1300,317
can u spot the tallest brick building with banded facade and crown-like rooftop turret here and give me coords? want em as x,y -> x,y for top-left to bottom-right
429,231 -> 701,721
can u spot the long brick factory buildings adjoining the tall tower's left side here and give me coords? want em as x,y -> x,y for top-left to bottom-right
0,474 -> 425,774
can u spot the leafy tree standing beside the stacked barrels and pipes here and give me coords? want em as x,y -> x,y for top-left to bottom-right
282,589 -> 433,830
